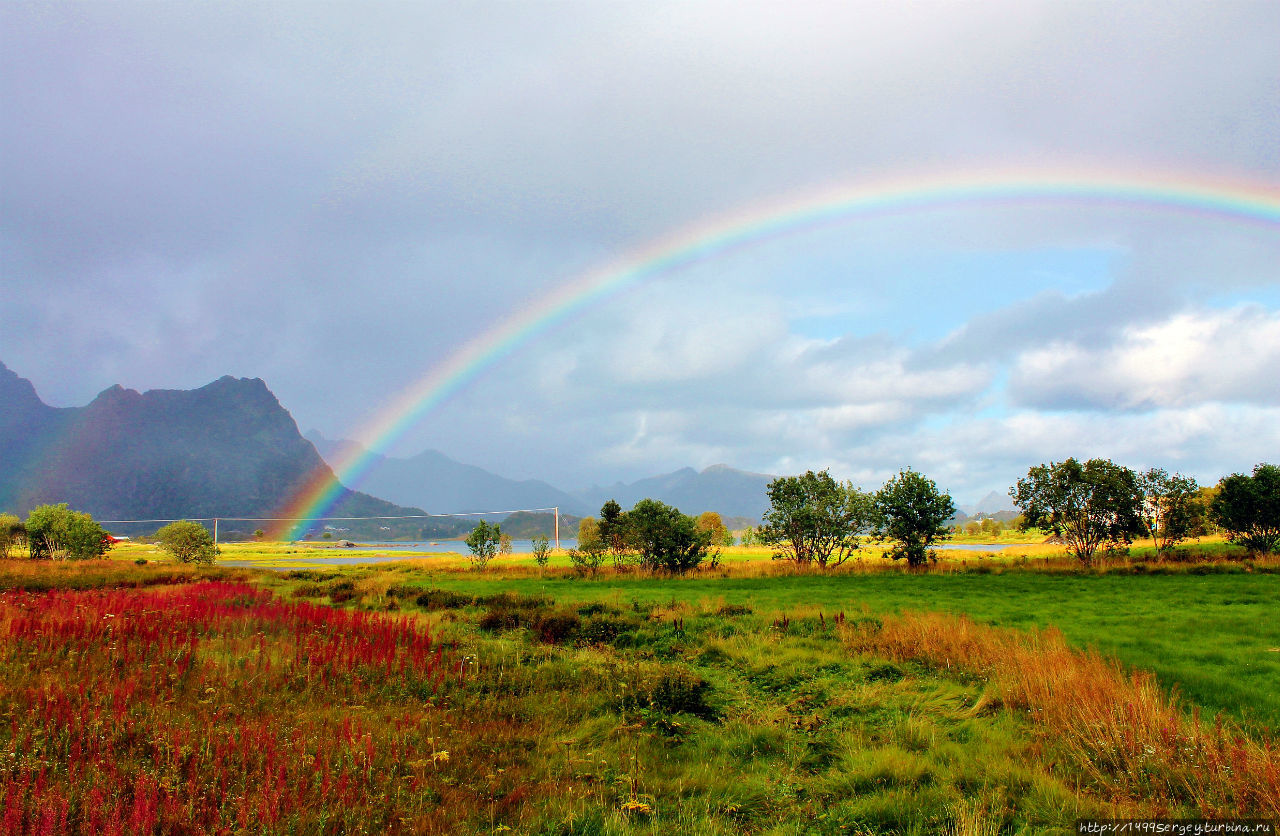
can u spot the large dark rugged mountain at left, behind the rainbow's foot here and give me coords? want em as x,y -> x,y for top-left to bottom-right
0,364 -> 435,530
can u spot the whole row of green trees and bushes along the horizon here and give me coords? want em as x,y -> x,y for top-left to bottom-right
0,458 -> 1280,574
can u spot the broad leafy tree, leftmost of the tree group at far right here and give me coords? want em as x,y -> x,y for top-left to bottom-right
1009,458 -> 1146,565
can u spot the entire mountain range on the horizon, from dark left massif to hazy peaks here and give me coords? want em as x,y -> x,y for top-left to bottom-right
0,362 -> 1010,539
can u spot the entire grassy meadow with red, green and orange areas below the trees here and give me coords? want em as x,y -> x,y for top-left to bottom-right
0,544 -> 1280,835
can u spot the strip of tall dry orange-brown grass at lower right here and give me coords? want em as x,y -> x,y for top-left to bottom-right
847,613 -> 1280,818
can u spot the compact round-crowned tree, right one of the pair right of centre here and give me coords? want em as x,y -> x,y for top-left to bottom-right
872,469 -> 956,566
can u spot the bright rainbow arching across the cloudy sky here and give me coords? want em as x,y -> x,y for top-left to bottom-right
264,170 -> 1280,539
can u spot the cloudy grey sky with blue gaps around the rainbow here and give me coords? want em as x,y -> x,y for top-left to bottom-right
0,0 -> 1280,503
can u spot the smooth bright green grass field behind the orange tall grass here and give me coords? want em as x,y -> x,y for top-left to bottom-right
252,566 -> 1280,728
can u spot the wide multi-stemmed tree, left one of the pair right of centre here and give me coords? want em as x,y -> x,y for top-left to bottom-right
756,470 -> 872,568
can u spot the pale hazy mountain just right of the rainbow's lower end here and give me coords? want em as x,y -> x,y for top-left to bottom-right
306,430 -> 598,515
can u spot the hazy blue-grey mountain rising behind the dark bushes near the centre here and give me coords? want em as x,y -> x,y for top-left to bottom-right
577,465 -> 774,522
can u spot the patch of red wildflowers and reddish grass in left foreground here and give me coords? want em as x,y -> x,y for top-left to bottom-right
0,583 -> 449,836
